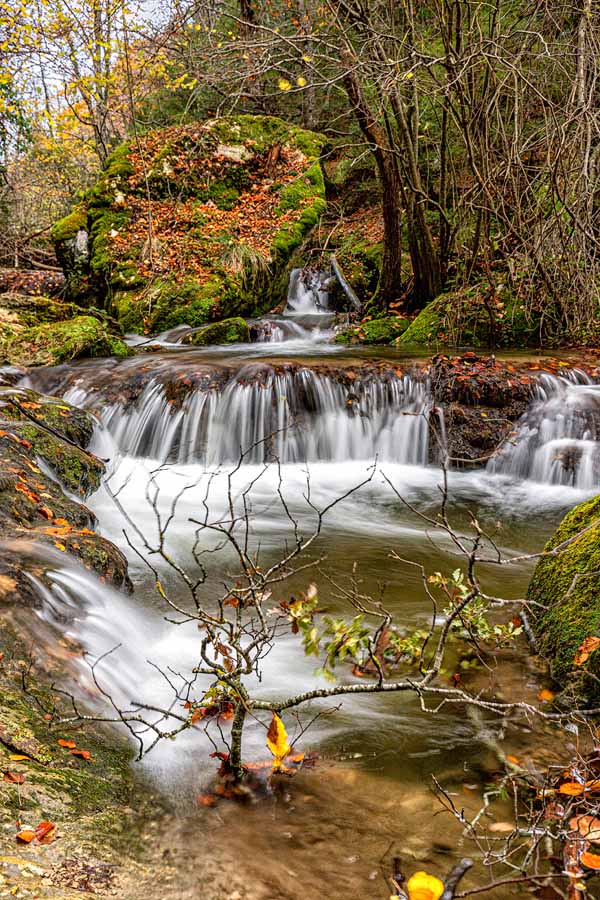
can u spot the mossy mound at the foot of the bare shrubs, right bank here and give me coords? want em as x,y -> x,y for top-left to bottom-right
399,285 -> 542,348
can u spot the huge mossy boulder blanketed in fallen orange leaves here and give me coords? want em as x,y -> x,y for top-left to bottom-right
54,115 -> 326,333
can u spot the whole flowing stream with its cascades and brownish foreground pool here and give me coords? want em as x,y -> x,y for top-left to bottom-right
14,270 -> 600,900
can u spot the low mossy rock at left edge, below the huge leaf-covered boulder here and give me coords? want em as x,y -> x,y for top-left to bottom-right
0,316 -> 132,366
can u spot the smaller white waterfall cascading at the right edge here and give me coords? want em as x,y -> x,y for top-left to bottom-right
487,369 -> 600,490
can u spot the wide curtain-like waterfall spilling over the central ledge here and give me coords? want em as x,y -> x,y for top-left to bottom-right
65,367 -> 432,465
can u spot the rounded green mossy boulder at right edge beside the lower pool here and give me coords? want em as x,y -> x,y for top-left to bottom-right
527,496 -> 600,707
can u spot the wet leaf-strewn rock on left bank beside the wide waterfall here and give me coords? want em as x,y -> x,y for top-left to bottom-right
0,388 -> 130,603
